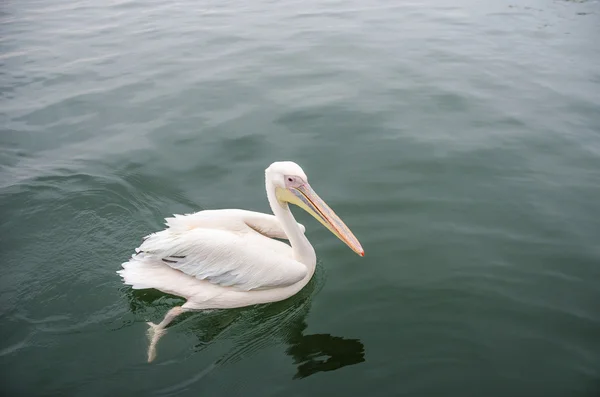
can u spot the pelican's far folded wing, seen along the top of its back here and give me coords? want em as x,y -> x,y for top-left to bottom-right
166,209 -> 305,239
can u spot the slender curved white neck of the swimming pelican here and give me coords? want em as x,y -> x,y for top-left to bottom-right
266,176 -> 317,267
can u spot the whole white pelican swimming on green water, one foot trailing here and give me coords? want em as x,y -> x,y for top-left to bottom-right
117,161 -> 364,362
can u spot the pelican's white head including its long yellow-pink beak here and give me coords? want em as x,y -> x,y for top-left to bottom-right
265,161 -> 365,256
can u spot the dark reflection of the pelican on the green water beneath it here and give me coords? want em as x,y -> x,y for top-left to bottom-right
126,270 -> 365,380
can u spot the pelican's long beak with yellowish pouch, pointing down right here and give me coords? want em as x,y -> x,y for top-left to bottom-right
277,183 -> 365,256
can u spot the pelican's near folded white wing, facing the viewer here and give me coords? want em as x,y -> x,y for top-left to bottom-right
137,227 -> 307,291
